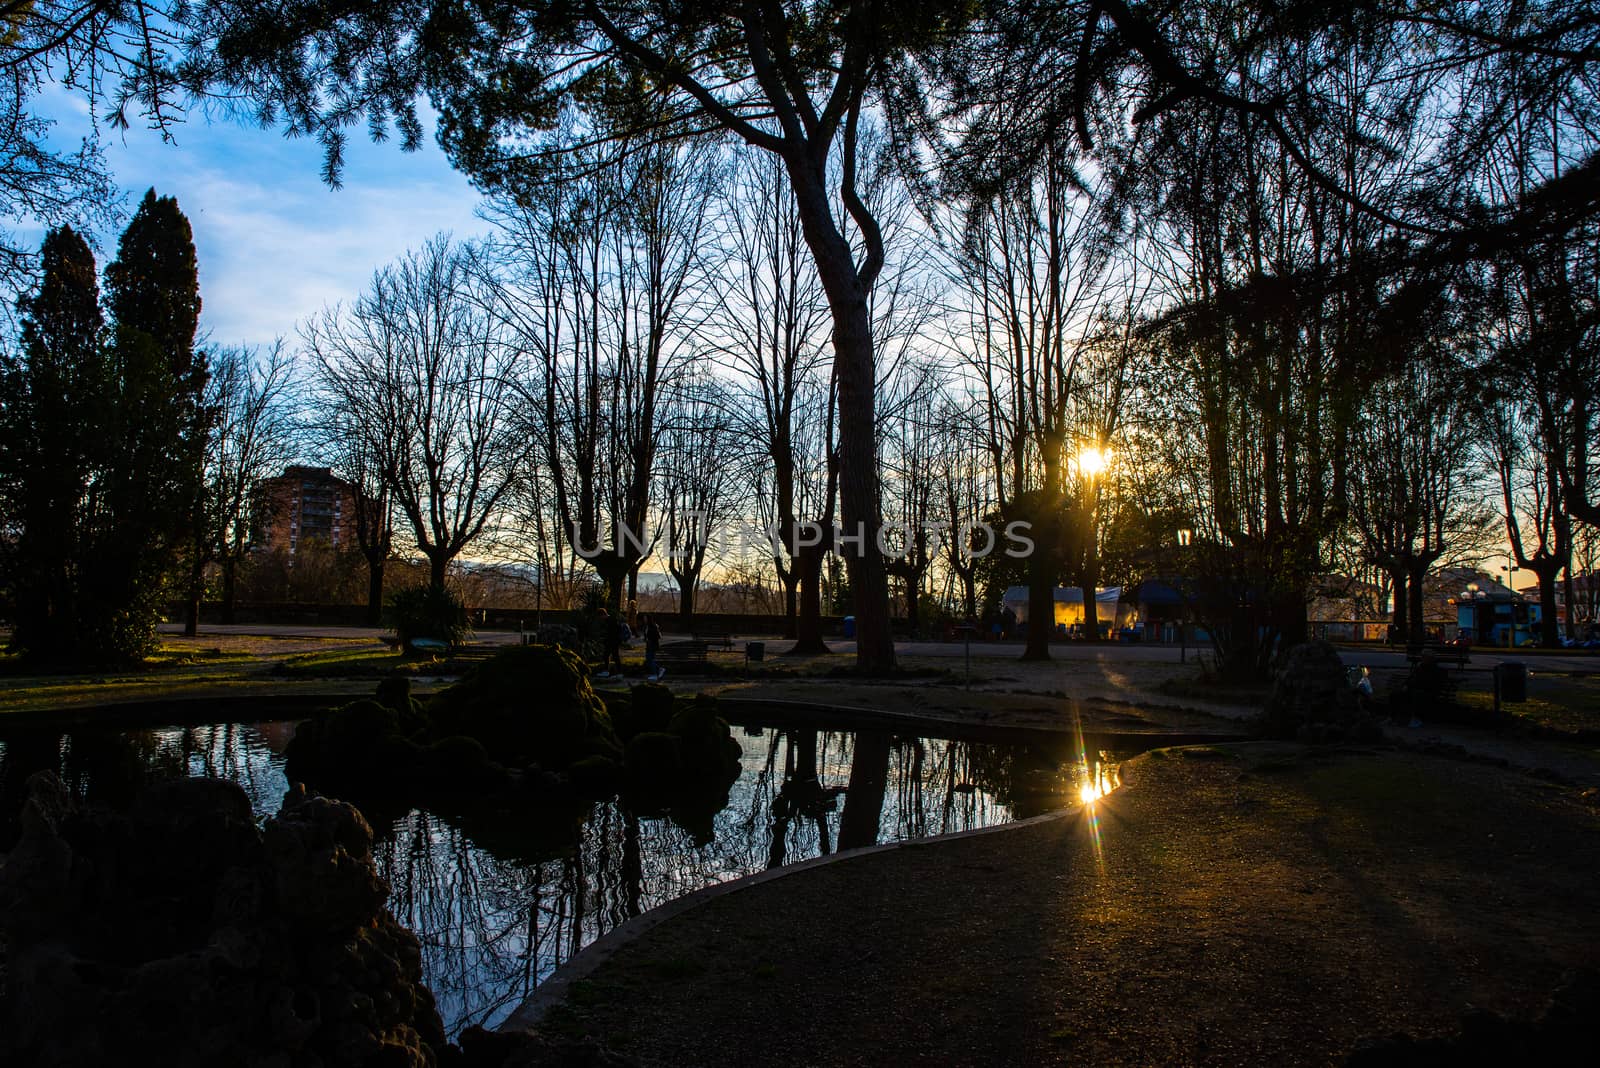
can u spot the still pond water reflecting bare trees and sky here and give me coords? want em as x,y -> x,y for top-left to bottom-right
0,723 -> 1120,1034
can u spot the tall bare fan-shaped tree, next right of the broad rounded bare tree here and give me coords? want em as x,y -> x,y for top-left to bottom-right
498,134 -> 720,611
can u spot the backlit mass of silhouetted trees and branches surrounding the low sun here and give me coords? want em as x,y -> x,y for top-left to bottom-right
6,0 -> 1600,675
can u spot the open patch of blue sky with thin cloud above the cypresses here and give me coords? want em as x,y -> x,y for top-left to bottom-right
21,91 -> 490,345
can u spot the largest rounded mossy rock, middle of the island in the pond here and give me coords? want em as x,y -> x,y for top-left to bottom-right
429,646 -> 616,767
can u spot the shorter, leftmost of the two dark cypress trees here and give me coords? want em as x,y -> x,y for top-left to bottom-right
0,225 -> 110,660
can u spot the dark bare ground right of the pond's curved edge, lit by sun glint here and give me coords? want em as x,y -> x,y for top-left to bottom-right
521,745 -> 1600,1065
